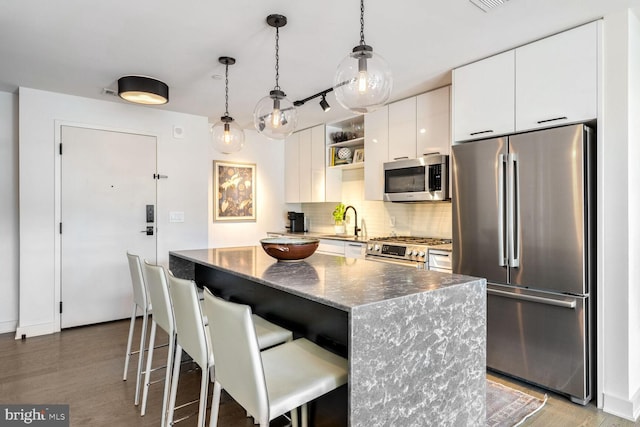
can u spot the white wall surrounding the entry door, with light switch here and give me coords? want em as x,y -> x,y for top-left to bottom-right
16,88 -> 211,337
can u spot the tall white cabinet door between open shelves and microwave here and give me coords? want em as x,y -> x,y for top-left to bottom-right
364,106 -> 389,200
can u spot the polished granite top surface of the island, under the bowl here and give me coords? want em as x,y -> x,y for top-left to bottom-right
170,246 -> 480,311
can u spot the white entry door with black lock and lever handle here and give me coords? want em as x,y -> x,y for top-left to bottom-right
60,126 -> 156,328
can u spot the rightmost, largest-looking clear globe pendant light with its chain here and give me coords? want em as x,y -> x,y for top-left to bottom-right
333,0 -> 393,114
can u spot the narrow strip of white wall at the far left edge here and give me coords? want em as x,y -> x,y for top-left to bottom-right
0,92 -> 19,334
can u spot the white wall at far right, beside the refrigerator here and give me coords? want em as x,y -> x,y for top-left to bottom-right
598,11 -> 640,419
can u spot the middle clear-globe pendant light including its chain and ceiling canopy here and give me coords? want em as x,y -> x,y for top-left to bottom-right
253,15 -> 298,139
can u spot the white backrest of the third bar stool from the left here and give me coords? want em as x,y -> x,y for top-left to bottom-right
169,274 -> 209,375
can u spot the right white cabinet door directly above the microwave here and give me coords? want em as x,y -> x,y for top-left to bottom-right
416,86 -> 451,157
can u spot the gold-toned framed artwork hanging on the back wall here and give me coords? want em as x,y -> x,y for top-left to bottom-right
213,160 -> 256,222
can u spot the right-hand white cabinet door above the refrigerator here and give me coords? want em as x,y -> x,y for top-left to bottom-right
516,22 -> 598,131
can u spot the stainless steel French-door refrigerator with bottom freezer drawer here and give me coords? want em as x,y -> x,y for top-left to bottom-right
452,124 -> 595,404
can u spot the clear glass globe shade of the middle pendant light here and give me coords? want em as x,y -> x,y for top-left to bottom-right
253,90 -> 298,140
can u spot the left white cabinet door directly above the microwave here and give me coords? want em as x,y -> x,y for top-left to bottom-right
389,96 -> 416,160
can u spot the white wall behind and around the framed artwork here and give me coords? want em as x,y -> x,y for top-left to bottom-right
209,130 -> 286,247
